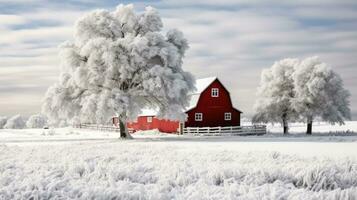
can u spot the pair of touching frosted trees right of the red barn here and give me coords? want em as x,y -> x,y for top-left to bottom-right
253,56 -> 351,134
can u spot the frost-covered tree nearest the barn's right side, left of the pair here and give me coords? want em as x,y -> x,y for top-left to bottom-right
252,59 -> 299,134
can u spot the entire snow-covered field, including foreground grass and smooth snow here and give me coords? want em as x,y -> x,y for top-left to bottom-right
0,122 -> 357,199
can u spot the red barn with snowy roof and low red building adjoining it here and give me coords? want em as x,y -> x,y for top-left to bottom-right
114,77 -> 242,133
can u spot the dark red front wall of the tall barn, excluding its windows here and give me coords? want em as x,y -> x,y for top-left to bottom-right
185,80 -> 240,127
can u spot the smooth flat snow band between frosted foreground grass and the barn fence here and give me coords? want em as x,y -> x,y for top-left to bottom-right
0,128 -> 357,157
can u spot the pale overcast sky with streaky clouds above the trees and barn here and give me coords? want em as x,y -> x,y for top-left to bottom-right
0,0 -> 357,119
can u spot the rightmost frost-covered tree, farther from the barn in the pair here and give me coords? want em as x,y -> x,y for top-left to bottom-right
293,56 -> 351,134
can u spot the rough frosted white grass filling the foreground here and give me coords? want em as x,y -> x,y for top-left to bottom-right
0,140 -> 357,199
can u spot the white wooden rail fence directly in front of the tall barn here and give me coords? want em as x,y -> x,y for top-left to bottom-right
183,125 -> 266,136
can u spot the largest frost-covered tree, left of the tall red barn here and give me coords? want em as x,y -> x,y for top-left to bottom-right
43,5 -> 194,137
